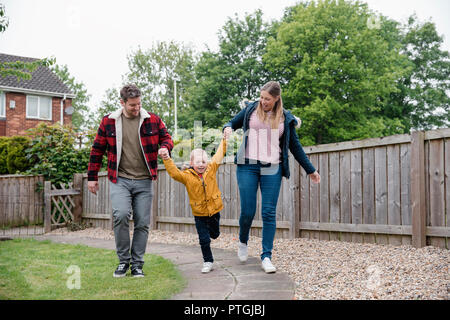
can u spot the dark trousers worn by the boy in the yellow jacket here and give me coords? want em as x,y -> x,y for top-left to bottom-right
194,212 -> 220,262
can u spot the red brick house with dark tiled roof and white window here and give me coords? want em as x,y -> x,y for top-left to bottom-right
0,53 -> 75,136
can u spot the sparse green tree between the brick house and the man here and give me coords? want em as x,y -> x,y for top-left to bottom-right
52,65 -> 92,131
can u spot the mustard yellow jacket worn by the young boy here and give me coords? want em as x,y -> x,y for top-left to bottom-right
164,139 -> 227,216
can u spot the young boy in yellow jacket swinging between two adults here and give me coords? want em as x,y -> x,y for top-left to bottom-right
162,135 -> 228,273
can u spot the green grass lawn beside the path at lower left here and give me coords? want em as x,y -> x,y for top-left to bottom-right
0,239 -> 186,300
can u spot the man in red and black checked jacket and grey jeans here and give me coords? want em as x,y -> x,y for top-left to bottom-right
88,85 -> 173,277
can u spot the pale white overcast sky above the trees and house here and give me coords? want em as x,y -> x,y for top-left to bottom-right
0,0 -> 450,113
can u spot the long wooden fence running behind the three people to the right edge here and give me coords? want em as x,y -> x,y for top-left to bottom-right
82,129 -> 450,248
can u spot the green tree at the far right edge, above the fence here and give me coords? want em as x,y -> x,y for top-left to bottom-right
389,15 -> 450,132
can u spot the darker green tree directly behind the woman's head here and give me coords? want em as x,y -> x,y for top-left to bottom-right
185,10 -> 272,127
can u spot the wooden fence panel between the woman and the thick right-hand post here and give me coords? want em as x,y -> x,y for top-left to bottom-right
300,135 -> 411,245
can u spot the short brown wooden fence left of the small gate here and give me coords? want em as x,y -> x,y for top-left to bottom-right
0,175 -> 44,236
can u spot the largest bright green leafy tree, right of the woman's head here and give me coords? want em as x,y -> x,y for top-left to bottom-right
263,0 -> 410,145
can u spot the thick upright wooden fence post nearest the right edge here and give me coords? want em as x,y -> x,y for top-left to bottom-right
410,131 -> 426,248
